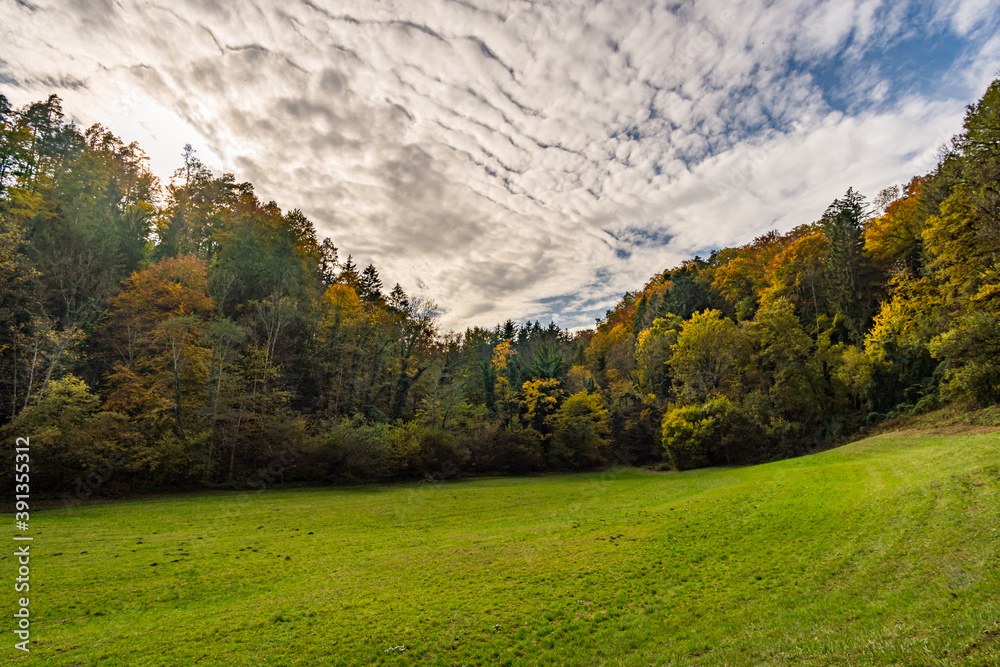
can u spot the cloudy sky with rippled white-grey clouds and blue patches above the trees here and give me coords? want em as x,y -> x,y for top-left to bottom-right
0,0 -> 1000,330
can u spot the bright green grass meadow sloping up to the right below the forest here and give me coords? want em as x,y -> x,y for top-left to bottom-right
9,433 -> 1000,666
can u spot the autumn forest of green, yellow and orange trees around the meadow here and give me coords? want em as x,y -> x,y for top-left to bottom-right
0,79 -> 1000,499
